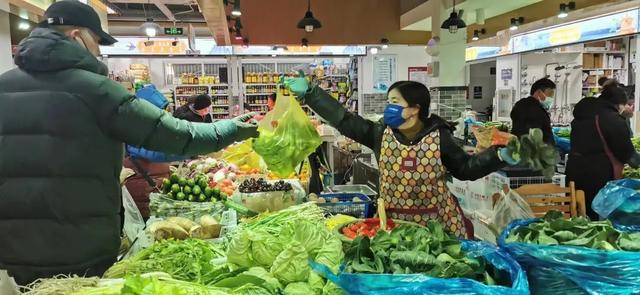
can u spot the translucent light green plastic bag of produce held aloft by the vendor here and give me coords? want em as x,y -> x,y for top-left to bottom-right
253,92 -> 322,177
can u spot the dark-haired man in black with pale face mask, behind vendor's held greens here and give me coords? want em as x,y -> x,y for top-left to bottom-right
511,78 -> 556,145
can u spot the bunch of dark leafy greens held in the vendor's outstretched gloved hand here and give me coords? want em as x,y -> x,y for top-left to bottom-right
507,128 -> 558,178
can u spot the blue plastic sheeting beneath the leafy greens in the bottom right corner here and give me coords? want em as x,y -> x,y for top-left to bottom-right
498,219 -> 640,295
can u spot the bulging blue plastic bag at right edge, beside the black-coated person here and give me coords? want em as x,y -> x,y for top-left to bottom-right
591,179 -> 640,231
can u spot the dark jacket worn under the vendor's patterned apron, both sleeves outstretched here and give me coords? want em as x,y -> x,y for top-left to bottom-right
302,86 -> 506,180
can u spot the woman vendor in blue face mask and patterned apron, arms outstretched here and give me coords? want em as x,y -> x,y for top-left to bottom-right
285,77 -> 517,238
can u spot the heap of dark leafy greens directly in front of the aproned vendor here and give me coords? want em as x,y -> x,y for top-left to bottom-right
345,221 -> 496,285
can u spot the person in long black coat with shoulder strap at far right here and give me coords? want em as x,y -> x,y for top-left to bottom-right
567,83 -> 640,220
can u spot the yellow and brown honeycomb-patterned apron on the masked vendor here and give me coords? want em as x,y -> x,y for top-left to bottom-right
378,127 -> 468,238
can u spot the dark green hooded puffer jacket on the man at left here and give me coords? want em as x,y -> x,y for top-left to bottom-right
0,28 -> 237,284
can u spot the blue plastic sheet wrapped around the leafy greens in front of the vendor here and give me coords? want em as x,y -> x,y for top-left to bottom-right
311,241 -> 529,295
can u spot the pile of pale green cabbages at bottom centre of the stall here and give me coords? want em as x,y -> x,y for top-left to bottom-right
227,203 -> 344,295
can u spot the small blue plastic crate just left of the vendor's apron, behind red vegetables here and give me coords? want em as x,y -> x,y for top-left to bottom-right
318,193 -> 371,218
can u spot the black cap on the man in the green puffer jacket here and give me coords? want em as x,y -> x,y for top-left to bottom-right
39,0 -> 118,45
